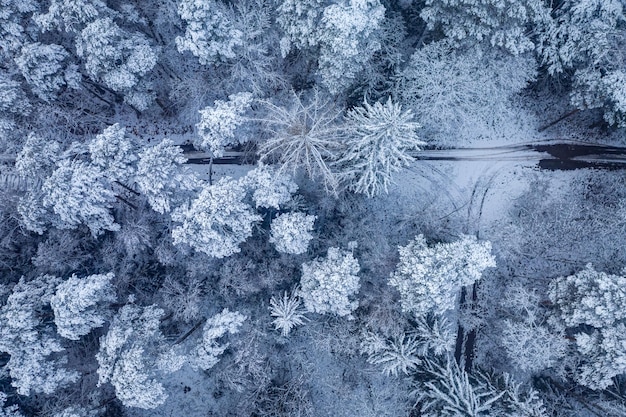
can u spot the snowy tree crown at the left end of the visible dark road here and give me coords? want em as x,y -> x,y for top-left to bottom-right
135,139 -> 188,213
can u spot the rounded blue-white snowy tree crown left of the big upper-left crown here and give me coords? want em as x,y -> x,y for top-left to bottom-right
15,42 -> 81,101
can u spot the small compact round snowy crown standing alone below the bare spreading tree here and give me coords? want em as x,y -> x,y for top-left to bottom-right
270,213 -> 316,255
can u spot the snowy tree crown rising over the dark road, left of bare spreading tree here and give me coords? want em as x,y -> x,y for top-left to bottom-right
194,93 -> 252,157
